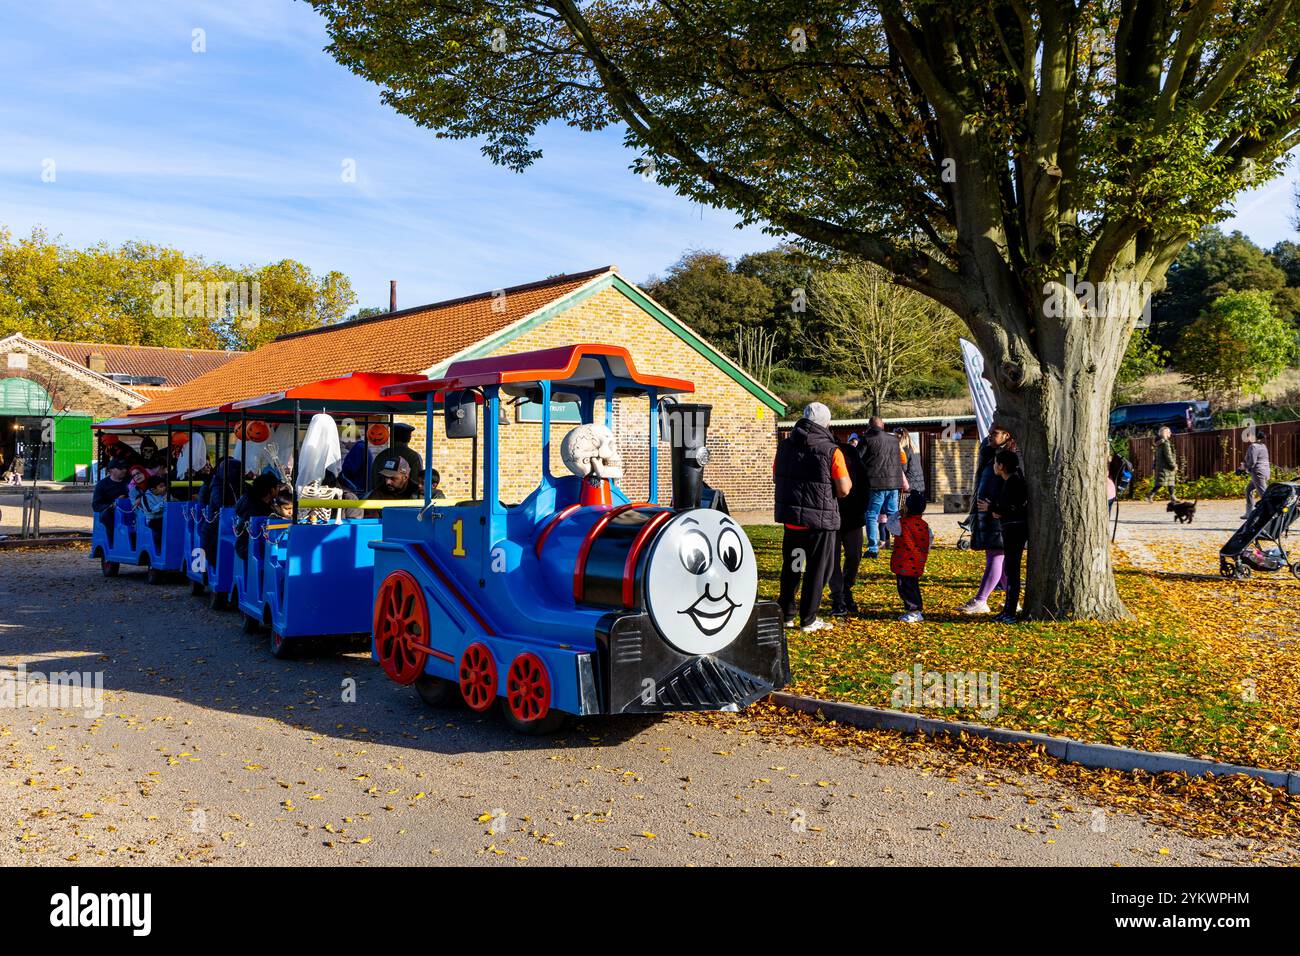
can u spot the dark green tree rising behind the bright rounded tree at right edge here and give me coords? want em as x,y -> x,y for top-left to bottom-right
1152,226 -> 1300,349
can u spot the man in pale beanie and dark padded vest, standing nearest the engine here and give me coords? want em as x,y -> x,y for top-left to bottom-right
772,402 -> 852,631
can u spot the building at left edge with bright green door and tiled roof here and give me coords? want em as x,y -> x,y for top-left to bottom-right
0,333 -> 235,481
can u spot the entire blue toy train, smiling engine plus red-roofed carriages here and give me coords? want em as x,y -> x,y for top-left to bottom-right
92,345 -> 789,734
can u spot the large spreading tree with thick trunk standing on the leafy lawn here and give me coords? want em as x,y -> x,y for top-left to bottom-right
301,0 -> 1300,618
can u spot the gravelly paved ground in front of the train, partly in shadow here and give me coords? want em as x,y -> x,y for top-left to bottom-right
0,551 -> 1279,865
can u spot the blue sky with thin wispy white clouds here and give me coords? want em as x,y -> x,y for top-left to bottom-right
0,0 -> 1300,314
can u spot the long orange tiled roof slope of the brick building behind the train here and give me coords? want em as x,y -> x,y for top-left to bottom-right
131,267 -> 610,415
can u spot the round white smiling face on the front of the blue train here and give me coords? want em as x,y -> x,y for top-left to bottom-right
645,509 -> 758,654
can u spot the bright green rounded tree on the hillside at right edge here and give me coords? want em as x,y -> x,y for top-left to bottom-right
1177,289 -> 1296,401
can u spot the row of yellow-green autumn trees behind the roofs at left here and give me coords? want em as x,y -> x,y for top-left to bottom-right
0,229 -> 356,349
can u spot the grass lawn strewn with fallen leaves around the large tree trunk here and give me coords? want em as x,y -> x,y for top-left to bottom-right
746,525 -> 1300,770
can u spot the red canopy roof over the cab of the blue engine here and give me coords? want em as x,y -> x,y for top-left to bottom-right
384,343 -> 696,395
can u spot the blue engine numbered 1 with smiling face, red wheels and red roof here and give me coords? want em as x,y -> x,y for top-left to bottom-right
371,345 -> 789,732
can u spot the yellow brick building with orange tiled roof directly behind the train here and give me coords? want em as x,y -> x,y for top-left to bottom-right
133,267 -> 784,510
